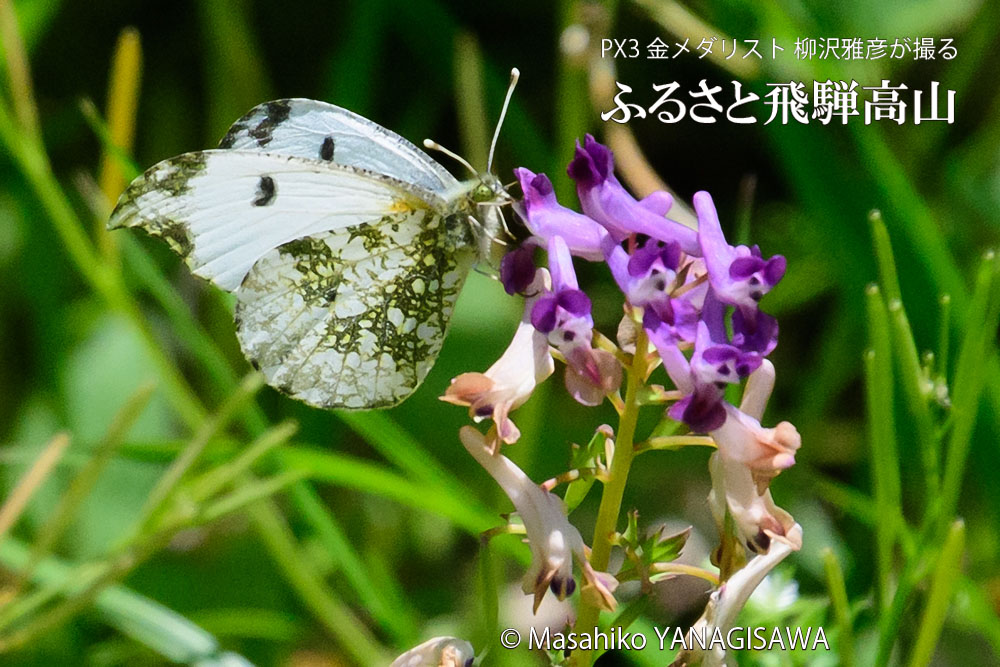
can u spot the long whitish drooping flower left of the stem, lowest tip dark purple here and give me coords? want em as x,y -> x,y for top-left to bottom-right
459,426 -> 618,611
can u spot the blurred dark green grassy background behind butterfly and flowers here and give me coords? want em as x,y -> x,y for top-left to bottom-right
0,0 -> 1000,665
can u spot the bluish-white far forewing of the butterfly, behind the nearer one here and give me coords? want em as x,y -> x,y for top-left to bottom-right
219,99 -> 458,193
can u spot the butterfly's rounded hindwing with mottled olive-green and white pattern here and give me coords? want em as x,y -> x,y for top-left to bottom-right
236,211 -> 474,409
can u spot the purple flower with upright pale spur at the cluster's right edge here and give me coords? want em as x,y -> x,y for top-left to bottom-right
694,191 -> 785,314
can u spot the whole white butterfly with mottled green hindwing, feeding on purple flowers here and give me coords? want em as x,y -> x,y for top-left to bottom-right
108,69 -> 517,410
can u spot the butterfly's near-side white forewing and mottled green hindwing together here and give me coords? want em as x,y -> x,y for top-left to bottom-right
109,150 -> 475,409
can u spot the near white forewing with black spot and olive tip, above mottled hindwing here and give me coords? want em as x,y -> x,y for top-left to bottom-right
108,150 -> 446,291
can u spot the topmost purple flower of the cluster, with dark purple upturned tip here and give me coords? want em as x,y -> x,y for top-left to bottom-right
567,134 -> 701,255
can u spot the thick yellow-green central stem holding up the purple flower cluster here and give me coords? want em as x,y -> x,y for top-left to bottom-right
572,329 -> 648,667
